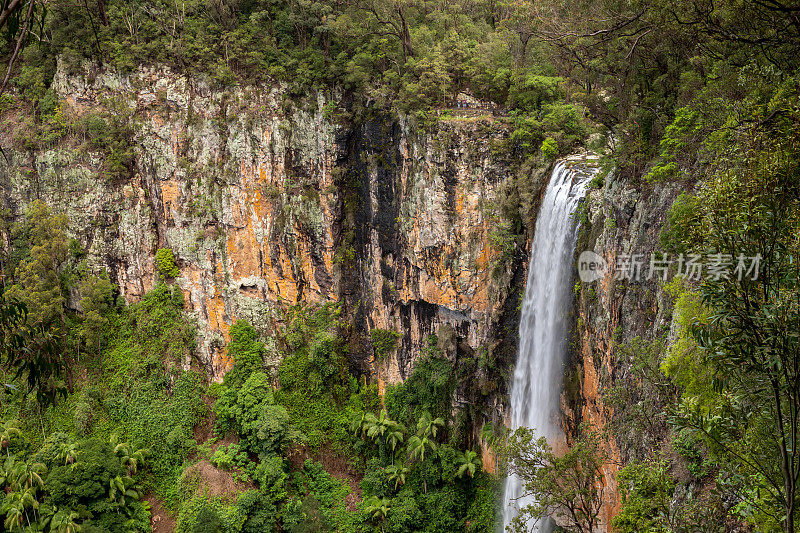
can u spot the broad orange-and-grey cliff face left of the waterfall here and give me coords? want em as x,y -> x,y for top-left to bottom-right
0,60 -> 543,389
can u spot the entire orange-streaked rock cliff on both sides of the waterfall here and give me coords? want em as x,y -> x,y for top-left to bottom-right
0,63 -> 678,524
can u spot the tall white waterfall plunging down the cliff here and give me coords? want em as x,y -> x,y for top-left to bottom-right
503,162 -> 596,531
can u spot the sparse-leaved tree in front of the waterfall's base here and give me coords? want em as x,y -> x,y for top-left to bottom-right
502,427 -> 606,533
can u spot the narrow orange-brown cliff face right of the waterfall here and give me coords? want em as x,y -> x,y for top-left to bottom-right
564,171 -> 680,528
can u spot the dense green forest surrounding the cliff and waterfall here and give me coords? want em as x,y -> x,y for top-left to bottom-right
0,0 -> 800,533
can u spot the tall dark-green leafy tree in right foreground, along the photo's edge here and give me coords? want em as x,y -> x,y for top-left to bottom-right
674,116 -> 800,533
